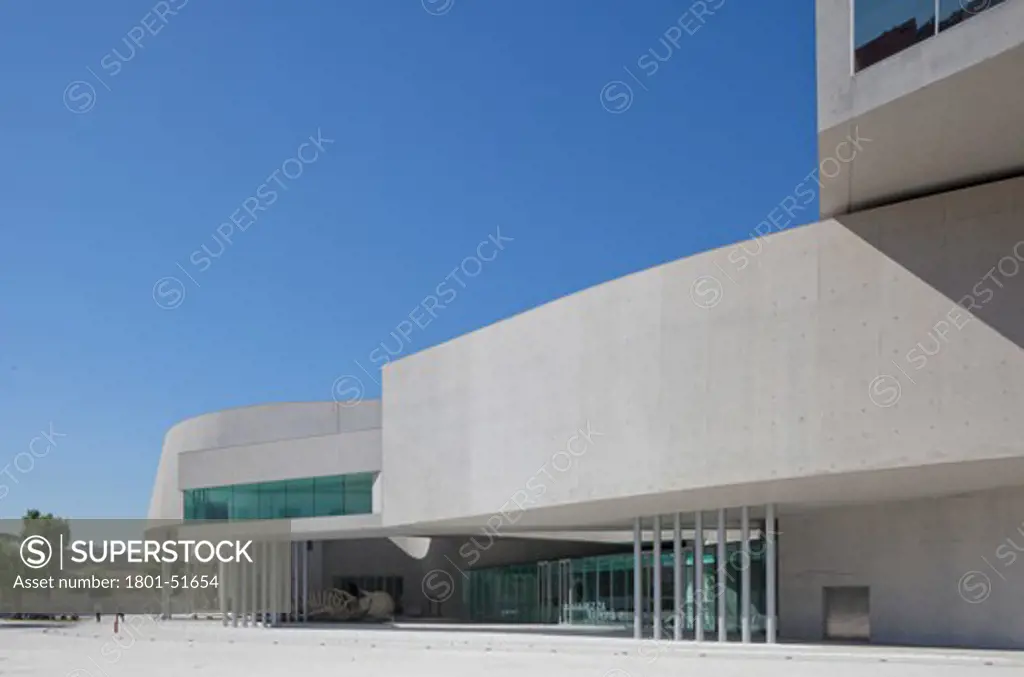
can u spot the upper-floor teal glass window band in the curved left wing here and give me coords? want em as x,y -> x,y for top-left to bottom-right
183,472 -> 375,520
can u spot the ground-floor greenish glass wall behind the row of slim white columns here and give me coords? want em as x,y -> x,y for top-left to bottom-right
463,540 -> 765,634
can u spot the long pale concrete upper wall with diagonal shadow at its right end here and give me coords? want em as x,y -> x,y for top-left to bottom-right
383,179 -> 1024,526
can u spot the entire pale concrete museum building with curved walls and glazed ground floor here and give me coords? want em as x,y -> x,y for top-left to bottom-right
150,0 -> 1024,648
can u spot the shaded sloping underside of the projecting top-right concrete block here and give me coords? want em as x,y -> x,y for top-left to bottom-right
818,39 -> 1024,218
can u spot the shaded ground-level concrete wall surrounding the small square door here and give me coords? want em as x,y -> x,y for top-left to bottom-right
779,488 -> 1024,648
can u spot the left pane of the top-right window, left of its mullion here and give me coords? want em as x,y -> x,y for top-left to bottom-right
853,0 -> 937,71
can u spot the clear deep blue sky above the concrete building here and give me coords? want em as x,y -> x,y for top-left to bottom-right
0,0 -> 816,517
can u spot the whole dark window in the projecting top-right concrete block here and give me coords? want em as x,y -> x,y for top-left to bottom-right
853,0 -> 1008,72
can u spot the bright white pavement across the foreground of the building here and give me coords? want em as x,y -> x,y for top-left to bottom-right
0,617 -> 1024,677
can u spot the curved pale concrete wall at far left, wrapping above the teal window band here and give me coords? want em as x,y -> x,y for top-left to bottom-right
150,400 -> 381,519
